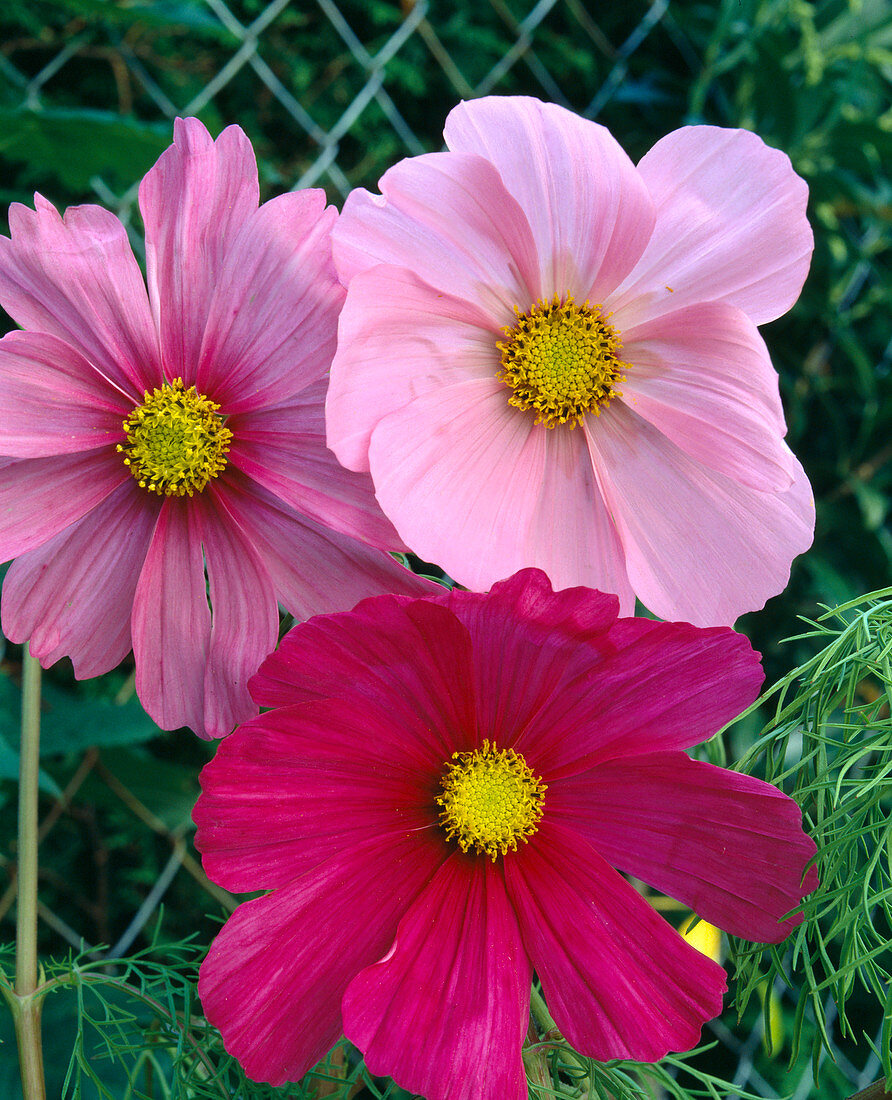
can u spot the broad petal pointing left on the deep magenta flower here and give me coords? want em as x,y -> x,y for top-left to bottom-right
192,699 -> 452,891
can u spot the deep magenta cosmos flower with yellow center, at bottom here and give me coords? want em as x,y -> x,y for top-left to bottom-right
195,570 -> 815,1100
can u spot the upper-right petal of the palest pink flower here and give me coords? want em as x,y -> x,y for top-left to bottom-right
609,127 -> 813,326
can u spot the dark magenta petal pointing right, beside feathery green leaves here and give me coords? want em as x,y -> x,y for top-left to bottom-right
548,752 -> 817,944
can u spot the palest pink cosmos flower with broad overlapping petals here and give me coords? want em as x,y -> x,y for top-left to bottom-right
327,98 -> 814,626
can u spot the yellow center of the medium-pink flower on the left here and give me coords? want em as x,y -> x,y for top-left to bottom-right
118,378 -> 232,496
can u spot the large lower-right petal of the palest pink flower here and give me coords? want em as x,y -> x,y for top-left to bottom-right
585,402 -> 815,626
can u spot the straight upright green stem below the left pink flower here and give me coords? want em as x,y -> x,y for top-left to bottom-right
13,651 -> 46,1100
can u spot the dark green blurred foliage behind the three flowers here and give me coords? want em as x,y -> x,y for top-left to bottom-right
0,0 -> 892,1100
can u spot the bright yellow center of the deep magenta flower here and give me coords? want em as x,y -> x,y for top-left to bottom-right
437,741 -> 547,861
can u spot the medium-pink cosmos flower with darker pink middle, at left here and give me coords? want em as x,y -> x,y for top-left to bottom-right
0,119 -> 428,736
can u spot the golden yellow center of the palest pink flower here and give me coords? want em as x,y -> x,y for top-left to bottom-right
496,294 -> 628,428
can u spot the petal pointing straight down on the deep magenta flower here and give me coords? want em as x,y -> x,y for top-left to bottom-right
343,853 -> 532,1100
